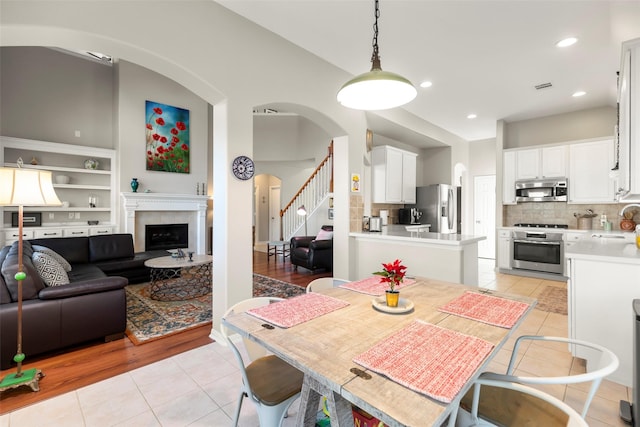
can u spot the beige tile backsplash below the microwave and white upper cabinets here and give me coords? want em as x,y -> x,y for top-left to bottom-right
502,202 -> 640,230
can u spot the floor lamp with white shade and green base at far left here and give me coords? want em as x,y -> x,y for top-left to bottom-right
0,165 -> 62,391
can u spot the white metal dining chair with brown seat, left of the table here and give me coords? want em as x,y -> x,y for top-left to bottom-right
220,297 -> 303,427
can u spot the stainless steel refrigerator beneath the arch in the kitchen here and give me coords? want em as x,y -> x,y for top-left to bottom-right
407,184 -> 461,233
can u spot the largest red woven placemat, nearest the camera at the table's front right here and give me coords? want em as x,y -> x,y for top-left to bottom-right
353,320 -> 493,403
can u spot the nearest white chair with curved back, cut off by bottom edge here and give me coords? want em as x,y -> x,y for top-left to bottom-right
455,375 -> 588,427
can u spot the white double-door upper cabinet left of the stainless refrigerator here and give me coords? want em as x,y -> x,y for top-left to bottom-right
371,145 -> 418,204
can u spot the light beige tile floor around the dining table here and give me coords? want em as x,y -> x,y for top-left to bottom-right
0,260 -> 631,427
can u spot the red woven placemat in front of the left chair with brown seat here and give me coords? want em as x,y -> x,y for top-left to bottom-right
247,292 -> 349,328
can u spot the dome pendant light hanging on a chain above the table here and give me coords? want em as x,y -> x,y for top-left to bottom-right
338,0 -> 417,110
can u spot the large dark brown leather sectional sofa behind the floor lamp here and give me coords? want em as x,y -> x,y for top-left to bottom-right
0,234 -> 167,369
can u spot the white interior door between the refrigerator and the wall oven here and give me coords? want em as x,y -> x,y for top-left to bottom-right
473,175 -> 496,259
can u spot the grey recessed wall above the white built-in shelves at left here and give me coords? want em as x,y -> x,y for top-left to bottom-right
0,47 -> 115,148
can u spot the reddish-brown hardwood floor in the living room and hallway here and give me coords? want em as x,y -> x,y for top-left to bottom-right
0,252 -> 331,415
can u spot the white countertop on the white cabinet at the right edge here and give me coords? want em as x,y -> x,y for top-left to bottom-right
565,236 -> 640,265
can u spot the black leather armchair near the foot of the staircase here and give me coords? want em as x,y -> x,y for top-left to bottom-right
291,225 -> 333,271
